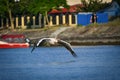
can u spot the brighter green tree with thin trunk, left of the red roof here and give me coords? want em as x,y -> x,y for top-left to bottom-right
28,0 -> 68,25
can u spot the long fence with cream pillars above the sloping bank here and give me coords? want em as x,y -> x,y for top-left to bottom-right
0,14 -> 77,29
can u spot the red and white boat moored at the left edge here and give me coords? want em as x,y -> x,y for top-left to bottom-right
0,34 -> 29,48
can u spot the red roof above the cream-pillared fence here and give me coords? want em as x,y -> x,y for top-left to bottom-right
49,4 -> 82,14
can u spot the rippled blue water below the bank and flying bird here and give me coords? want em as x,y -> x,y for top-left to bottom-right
0,46 -> 120,80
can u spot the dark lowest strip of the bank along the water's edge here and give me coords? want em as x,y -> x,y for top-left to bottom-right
31,39 -> 120,46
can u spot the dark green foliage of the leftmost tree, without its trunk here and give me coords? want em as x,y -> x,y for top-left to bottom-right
0,0 -> 30,15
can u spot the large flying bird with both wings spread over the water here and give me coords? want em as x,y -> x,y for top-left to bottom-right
31,38 -> 77,57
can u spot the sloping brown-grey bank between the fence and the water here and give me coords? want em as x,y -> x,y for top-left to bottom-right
0,26 -> 120,46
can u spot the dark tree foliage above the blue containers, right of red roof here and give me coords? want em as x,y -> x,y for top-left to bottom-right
79,0 -> 107,12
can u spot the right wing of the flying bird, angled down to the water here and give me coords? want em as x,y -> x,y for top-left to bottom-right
58,40 -> 77,57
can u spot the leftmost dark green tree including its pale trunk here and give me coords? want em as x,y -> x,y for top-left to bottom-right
0,0 -> 29,29
